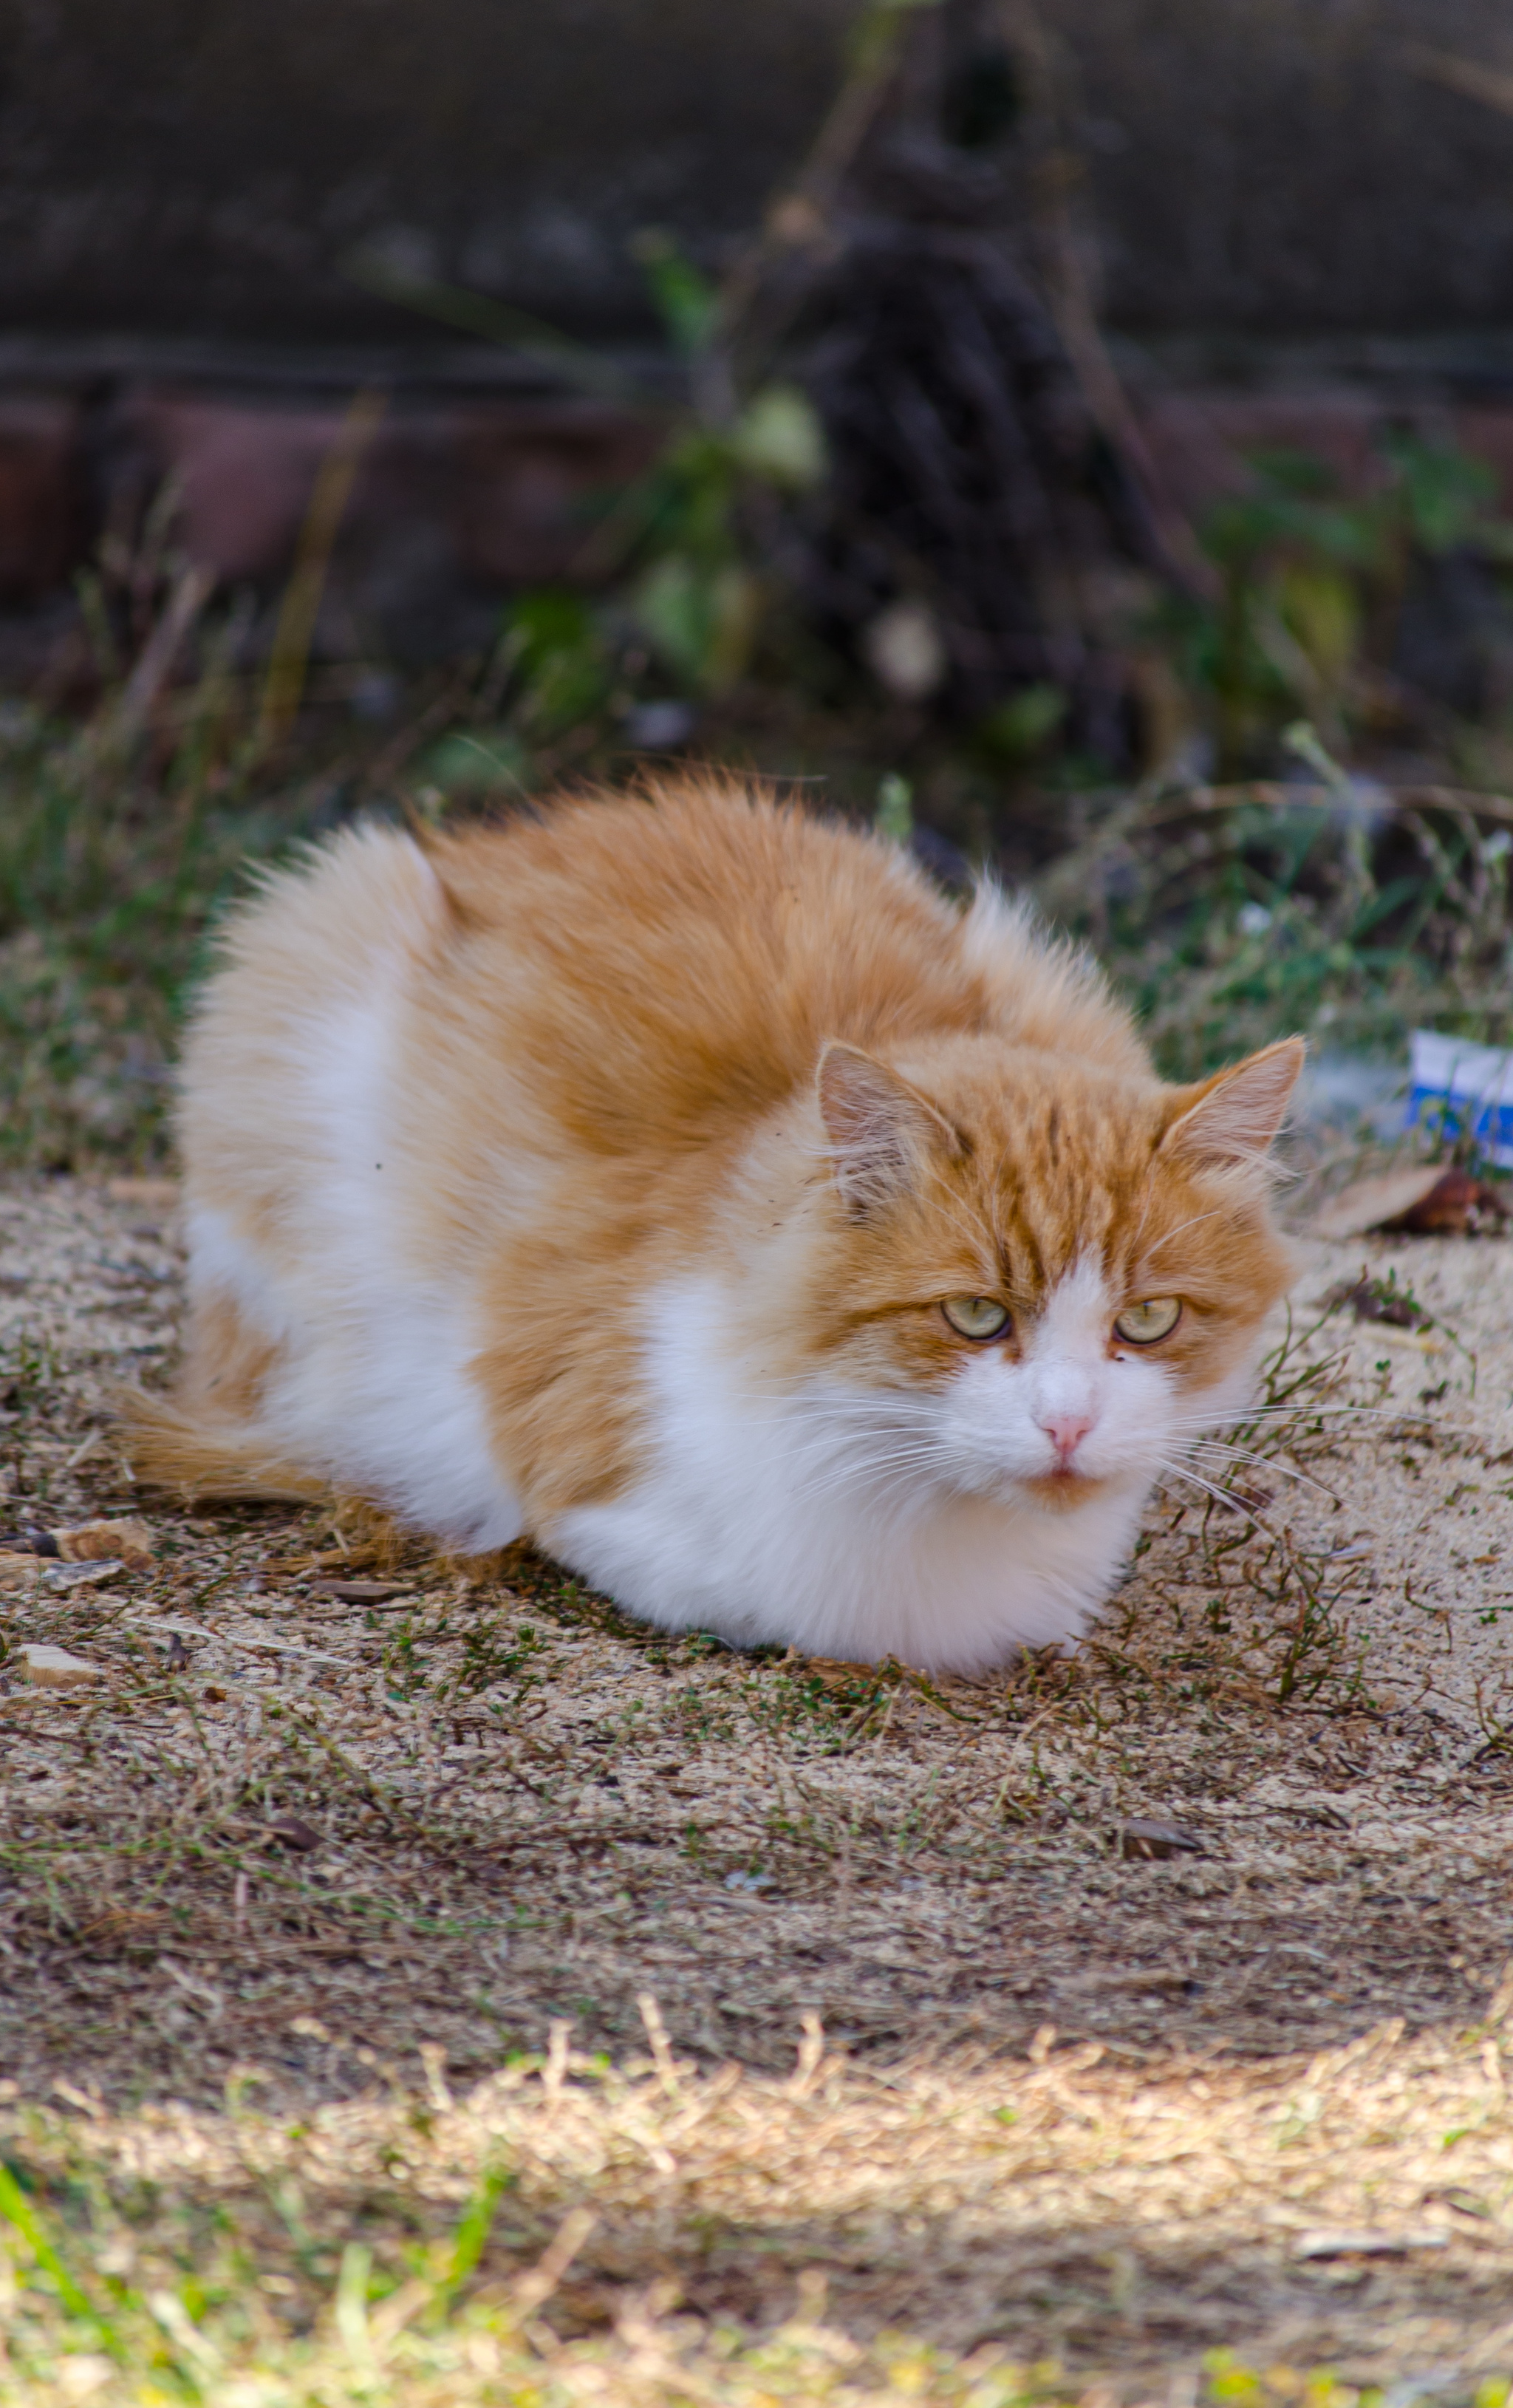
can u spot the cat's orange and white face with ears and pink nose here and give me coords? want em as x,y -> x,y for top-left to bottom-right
810,1040 -> 1303,1512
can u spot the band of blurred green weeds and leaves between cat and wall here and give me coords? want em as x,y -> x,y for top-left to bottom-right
0,414 -> 1513,1168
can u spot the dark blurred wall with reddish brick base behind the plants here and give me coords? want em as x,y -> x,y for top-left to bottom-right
0,0 -> 1513,675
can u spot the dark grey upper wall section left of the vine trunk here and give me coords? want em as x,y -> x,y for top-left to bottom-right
0,0 -> 853,342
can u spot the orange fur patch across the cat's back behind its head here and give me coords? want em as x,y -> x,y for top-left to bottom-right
419,773 -> 1150,1151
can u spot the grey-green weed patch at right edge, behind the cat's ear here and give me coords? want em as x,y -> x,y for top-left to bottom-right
1036,760 -> 1513,1079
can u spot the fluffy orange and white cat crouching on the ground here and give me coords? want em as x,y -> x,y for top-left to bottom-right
132,775 -> 1303,1671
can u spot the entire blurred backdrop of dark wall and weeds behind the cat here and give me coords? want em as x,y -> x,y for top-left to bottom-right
0,0 -> 1513,1168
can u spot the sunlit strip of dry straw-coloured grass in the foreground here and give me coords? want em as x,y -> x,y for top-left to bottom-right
0,1991 -> 1513,2408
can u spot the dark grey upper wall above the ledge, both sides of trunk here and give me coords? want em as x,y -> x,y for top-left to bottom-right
0,0 -> 1513,342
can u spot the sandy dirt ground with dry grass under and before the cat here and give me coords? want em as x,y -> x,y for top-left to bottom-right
0,1180 -> 1513,2403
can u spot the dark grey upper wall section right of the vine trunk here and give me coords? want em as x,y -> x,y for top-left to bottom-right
1059,0 -> 1513,335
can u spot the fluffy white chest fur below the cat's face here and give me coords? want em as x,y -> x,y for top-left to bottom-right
544,1283 -> 1150,1671
